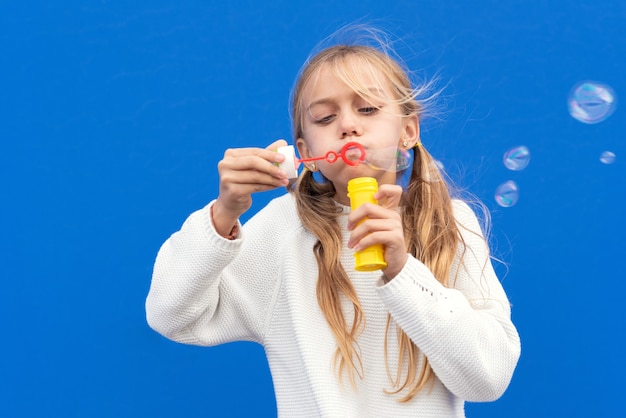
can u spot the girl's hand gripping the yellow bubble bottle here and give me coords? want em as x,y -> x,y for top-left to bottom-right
348,184 -> 408,280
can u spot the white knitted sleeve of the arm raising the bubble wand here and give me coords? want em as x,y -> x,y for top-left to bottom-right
146,202 -> 278,345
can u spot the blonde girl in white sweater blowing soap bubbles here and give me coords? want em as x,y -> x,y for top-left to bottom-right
146,27 -> 520,417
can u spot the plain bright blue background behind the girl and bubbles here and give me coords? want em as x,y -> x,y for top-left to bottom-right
0,0 -> 626,417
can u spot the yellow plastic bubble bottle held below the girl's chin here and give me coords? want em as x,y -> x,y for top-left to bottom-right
348,177 -> 387,271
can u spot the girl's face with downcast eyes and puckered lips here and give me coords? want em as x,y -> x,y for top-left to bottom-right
296,65 -> 419,205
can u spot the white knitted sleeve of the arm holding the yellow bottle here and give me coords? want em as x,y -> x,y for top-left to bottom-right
378,201 -> 520,402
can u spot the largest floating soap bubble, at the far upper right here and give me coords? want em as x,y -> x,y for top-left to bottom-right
567,81 -> 617,124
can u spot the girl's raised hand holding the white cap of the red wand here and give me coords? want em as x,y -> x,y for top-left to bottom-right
212,139 -> 289,236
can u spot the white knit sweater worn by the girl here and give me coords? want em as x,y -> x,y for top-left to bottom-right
146,194 -> 520,417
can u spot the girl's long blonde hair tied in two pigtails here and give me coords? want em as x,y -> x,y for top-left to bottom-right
289,33 -> 461,402
